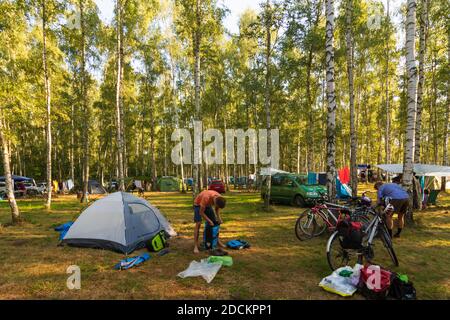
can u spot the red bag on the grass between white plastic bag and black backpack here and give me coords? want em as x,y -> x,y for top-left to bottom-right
358,265 -> 392,300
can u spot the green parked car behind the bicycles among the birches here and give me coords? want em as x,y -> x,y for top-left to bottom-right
261,173 -> 327,207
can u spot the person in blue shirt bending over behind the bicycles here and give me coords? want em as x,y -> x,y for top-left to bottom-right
374,181 -> 409,238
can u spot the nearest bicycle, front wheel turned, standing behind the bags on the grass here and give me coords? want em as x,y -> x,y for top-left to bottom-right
326,199 -> 399,271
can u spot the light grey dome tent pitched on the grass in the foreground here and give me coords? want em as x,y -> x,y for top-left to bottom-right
62,192 -> 176,254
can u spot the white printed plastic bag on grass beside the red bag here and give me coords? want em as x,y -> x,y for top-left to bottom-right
319,264 -> 362,297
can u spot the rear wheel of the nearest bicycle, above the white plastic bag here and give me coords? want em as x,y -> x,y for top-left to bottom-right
327,231 -> 362,271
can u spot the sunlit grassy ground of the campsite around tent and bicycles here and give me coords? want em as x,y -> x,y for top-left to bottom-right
0,185 -> 450,299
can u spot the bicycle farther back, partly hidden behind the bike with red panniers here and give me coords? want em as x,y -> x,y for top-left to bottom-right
295,194 -> 370,241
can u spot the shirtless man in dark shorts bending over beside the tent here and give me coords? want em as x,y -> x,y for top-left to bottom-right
194,190 -> 226,253
